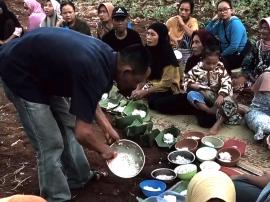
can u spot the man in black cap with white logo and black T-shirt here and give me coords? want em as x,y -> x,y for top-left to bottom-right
102,7 -> 142,51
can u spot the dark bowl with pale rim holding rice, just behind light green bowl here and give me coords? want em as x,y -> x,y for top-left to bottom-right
168,150 -> 195,165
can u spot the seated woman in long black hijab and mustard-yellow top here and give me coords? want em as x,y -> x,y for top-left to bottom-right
132,22 -> 180,110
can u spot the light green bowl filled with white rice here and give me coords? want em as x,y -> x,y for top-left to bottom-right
174,164 -> 197,180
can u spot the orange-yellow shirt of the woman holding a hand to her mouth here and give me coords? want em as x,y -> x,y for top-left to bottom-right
166,16 -> 199,46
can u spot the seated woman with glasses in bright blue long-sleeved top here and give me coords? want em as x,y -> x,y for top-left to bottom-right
206,0 -> 250,69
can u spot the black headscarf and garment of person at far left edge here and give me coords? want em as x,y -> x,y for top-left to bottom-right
0,0 -> 22,40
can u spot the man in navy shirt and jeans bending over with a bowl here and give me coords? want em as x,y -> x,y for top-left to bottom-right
0,28 -> 150,202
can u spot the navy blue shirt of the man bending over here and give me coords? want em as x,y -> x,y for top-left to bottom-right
0,28 -> 116,119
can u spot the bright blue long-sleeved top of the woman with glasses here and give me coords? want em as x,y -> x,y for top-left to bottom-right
206,16 -> 247,56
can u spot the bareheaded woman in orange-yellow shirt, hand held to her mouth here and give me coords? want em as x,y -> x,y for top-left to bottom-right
166,0 -> 199,49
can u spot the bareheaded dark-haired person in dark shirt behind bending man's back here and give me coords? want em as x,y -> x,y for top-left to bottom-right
57,1 -> 91,36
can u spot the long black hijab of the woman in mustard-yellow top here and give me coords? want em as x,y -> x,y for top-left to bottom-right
146,22 -> 179,80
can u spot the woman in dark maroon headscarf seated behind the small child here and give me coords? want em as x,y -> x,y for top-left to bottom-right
184,29 -> 230,73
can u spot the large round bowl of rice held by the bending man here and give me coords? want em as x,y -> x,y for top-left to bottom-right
107,139 -> 145,178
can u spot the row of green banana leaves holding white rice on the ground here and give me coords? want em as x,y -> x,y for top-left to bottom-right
99,87 -> 180,148
